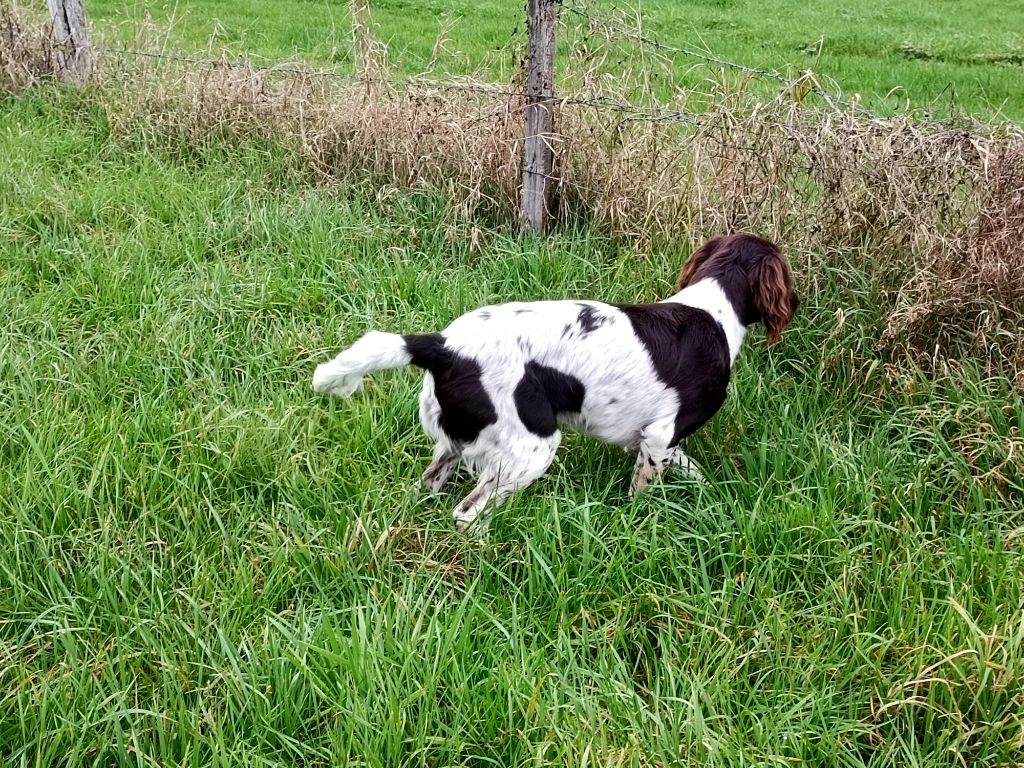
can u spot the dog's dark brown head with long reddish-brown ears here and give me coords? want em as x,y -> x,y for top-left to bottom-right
676,234 -> 800,343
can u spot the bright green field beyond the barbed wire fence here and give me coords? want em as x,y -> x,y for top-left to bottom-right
89,0 -> 1024,122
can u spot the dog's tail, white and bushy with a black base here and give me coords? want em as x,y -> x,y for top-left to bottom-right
313,331 -> 449,397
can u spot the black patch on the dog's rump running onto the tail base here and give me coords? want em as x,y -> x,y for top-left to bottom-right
402,334 -> 498,443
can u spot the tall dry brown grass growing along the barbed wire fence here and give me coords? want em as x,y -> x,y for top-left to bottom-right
6,0 -> 1024,383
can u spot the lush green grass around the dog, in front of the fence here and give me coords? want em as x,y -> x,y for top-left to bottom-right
0,92 -> 1024,768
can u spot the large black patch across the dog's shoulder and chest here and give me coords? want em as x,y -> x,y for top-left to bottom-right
618,303 -> 729,446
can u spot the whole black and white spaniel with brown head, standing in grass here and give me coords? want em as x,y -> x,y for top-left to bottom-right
313,234 -> 800,529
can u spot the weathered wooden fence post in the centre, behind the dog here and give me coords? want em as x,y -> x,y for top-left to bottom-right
519,0 -> 558,232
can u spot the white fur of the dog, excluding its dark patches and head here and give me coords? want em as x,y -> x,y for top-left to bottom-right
313,279 -> 746,528
